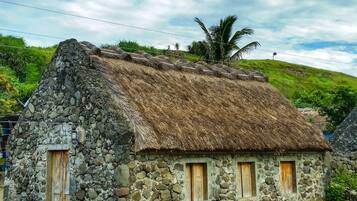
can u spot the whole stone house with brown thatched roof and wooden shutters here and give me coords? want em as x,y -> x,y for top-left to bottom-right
5,39 -> 330,201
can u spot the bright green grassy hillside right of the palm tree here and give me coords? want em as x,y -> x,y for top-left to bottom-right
234,60 -> 357,100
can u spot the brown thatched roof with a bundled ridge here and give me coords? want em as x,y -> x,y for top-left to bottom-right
79,40 -> 329,151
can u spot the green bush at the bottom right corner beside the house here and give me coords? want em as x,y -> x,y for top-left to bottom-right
326,170 -> 357,201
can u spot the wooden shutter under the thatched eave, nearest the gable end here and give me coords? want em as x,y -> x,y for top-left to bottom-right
185,163 -> 208,201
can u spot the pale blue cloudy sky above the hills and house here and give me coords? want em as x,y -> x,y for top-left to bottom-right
0,0 -> 357,76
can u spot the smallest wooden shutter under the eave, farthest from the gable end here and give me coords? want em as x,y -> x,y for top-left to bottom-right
280,161 -> 296,193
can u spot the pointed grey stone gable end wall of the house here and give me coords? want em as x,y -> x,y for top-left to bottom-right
5,39 -> 133,201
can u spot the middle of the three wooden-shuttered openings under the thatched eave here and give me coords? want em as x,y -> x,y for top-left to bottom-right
237,162 -> 256,197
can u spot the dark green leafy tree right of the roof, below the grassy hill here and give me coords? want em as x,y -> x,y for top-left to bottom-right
295,86 -> 357,131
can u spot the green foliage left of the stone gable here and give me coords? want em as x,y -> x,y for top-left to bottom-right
0,35 -> 55,114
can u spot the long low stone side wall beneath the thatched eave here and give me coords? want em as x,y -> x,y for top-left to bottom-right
115,153 -> 325,201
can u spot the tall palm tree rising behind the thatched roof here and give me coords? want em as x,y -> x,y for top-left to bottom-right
195,15 -> 260,61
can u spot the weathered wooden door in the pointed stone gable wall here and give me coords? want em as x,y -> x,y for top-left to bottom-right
46,150 -> 70,201
